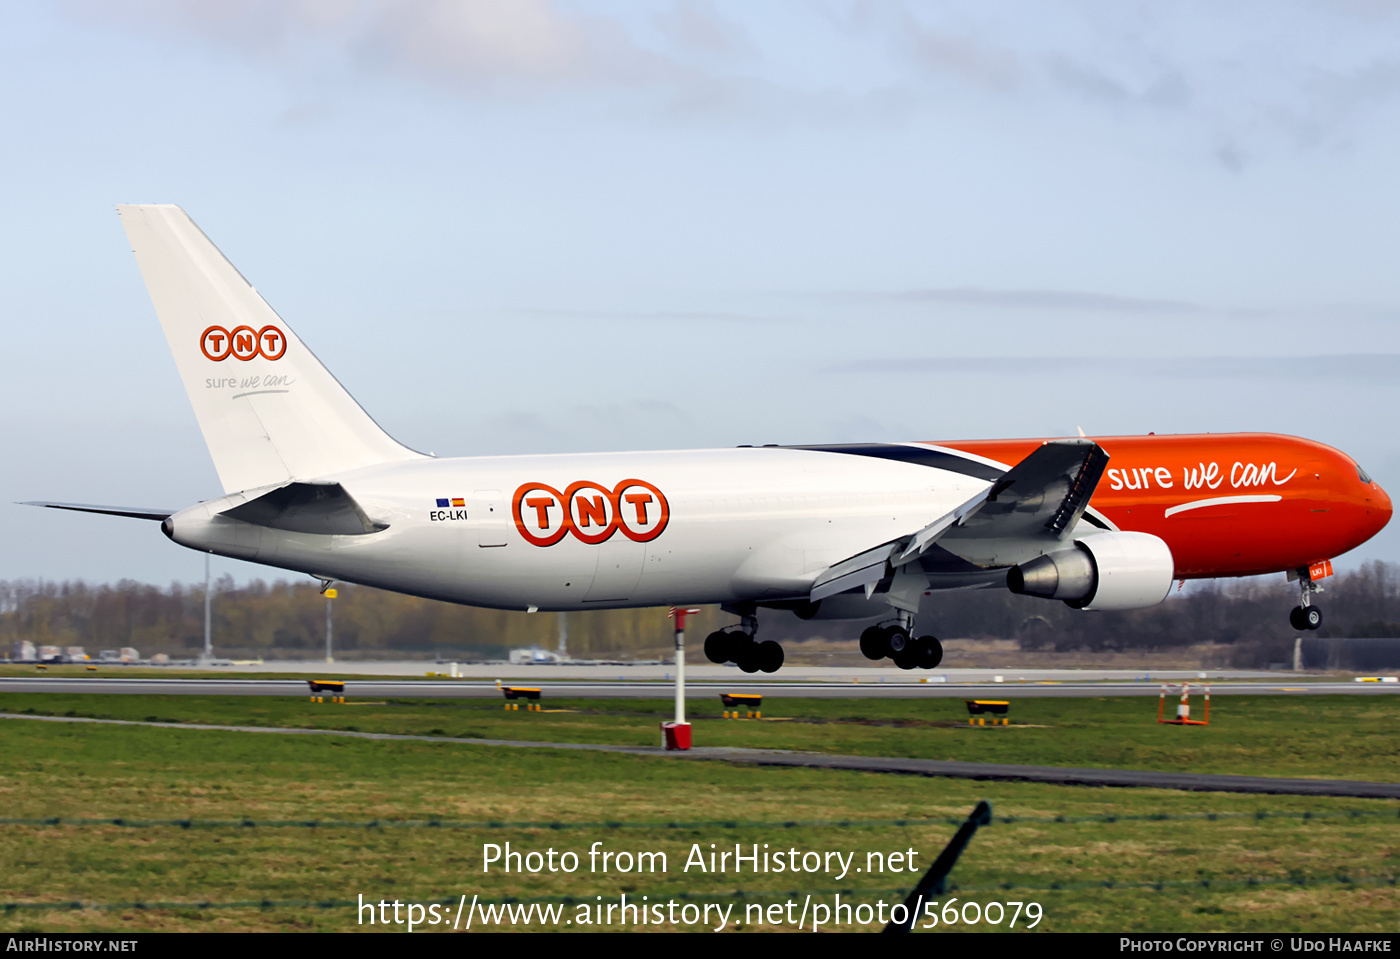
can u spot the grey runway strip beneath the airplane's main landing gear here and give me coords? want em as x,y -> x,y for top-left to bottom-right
0,671 -> 1400,699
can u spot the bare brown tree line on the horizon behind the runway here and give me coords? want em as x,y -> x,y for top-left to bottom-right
0,561 -> 1400,658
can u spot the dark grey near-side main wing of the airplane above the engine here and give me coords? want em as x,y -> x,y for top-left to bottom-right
809,440 -> 1109,602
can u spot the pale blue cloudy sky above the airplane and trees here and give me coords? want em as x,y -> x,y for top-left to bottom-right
8,0 -> 1400,584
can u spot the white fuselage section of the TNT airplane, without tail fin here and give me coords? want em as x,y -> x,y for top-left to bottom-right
169,447 -> 987,610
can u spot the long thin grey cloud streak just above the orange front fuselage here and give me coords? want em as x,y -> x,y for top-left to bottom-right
825,353 -> 1400,386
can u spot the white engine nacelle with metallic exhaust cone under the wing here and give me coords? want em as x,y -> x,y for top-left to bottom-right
1007,532 -> 1176,609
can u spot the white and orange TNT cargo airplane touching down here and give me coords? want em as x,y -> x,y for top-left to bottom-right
19,204 -> 1392,673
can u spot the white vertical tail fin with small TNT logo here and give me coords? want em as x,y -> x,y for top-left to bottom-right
116,204 -> 423,493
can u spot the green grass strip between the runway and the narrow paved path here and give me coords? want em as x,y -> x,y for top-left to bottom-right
0,693 -> 1400,783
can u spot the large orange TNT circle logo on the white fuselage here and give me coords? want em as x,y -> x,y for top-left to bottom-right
511,479 -> 671,546
